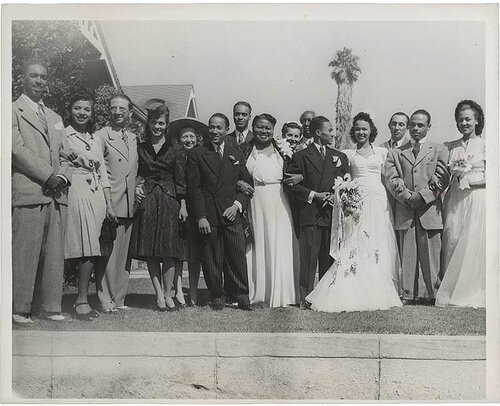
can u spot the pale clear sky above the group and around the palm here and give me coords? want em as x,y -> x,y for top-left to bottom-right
101,21 -> 485,144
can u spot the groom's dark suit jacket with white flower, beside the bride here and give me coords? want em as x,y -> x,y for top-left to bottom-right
290,144 -> 349,227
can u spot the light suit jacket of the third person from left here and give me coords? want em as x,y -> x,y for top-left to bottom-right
94,126 -> 138,218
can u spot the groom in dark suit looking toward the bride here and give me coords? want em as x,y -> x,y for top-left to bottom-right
291,116 -> 348,309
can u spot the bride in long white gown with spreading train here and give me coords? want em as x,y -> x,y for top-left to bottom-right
306,113 -> 402,312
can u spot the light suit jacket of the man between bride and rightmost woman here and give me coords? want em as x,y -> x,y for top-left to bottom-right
385,141 -> 449,230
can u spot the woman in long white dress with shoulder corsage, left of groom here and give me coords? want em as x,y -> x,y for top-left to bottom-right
243,114 -> 299,307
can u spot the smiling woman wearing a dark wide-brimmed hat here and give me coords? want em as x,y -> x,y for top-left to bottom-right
168,117 -> 208,306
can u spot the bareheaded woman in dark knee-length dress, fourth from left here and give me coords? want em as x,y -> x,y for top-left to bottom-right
130,99 -> 186,311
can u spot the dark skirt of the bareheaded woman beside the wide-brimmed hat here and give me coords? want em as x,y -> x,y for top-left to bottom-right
129,186 -> 186,261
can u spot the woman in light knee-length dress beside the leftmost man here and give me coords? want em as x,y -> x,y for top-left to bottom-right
65,95 -> 113,321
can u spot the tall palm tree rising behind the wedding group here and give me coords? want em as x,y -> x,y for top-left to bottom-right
328,47 -> 361,149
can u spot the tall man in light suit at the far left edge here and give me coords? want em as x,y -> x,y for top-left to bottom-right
12,60 -> 72,323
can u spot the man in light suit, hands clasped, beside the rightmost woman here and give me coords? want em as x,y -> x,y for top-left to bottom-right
385,110 -> 449,304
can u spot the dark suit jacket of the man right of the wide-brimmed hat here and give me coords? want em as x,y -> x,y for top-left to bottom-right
186,142 -> 253,226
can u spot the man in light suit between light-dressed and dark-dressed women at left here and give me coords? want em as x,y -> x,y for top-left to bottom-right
94,94 -> 138,312
